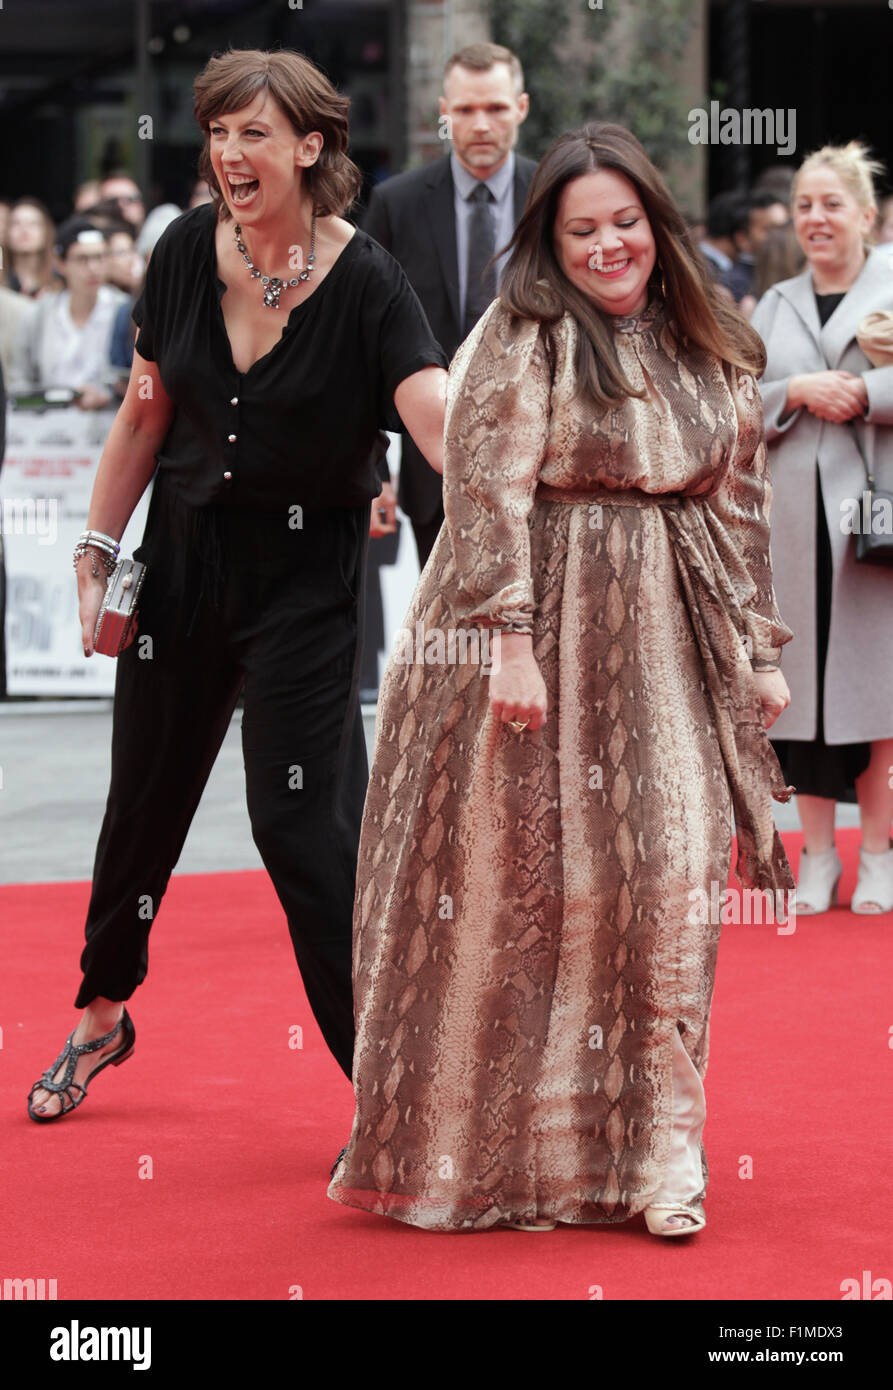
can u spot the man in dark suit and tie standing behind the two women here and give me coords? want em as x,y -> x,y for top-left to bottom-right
362,43 -> 536,569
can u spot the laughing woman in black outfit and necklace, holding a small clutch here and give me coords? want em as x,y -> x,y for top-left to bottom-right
28,51 -> 448,1120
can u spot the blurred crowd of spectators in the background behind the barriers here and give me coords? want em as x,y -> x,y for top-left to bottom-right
0,165 -> 893,410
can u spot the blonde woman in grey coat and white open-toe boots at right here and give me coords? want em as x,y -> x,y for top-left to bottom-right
751,142 -> 893,913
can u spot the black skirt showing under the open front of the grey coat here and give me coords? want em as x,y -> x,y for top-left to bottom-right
769,464 -> 871,802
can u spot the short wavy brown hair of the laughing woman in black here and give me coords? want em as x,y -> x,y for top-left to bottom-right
193,49 -> 363,221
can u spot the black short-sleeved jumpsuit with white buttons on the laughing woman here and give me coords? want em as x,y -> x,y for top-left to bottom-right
75,204 -> 448,1077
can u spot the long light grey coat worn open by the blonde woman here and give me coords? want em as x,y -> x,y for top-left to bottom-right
751,246 -> 893,744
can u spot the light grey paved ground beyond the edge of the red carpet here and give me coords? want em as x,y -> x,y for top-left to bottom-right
0,701 -> 858,883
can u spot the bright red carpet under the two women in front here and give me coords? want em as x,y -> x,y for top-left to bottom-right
0,830 -> 893,1301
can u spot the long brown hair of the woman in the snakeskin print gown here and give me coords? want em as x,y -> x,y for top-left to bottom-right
497,121 -> 766,410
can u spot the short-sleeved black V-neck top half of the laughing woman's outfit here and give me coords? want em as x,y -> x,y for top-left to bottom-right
134,203 -> 449,509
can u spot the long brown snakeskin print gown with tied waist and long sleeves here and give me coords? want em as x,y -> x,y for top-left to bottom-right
328,299 -> 794,1230
